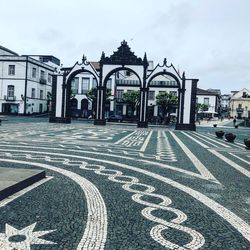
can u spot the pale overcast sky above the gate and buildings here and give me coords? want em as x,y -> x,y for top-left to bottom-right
0,0 -> 250,93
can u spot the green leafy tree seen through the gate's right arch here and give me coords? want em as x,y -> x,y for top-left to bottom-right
156,92 -> 178,117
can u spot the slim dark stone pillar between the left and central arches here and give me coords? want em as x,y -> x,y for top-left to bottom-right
94,86 -> 106,126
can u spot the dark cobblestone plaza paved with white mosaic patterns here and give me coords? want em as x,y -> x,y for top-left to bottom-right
0,118 -> 250,250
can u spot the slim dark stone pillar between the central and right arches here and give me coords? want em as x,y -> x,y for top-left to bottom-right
137,87 -> 148,128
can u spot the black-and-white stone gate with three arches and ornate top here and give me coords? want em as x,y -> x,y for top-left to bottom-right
49,41 -> 198,130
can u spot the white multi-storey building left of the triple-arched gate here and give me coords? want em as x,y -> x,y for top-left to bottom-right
0,46 -> 60,115
